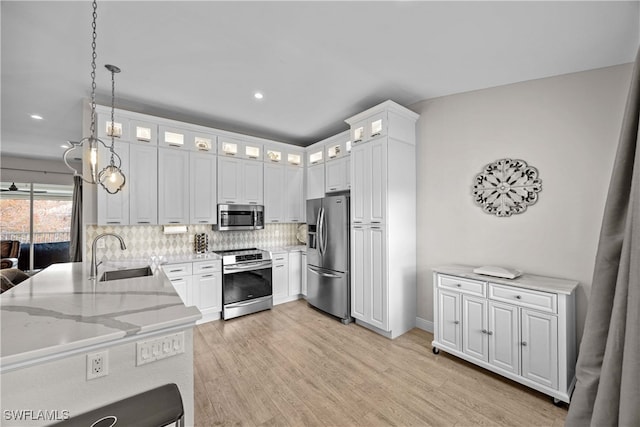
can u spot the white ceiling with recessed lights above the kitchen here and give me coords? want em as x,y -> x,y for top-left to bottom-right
0,0 -> 640,158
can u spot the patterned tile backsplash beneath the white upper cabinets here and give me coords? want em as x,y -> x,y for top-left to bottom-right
85,224 -> 301,261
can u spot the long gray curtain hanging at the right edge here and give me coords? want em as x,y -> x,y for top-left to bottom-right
566,47 -> 640,427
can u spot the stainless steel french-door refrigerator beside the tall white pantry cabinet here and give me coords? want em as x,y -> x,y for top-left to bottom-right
307,195 -> 352,323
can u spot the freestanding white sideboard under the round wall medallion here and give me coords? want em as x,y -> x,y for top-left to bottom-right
432,266 -> 578,403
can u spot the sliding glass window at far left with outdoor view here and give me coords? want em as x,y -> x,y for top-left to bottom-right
0,182 -> 73,271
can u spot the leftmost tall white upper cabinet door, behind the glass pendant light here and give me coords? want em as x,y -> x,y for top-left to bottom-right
96,141 -> 131,225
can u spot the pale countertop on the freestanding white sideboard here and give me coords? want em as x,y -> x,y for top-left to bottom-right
433,265 -> 580,295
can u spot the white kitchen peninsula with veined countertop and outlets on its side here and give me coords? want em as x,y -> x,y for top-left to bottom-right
0,263 -> 201,426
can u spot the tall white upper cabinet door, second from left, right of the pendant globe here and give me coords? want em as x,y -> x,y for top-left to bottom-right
127,144 -> 158,225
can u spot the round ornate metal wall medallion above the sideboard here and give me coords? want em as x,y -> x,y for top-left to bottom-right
473,159 -> 542,216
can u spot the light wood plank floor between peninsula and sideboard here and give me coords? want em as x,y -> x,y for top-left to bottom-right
194,300 -> 567,426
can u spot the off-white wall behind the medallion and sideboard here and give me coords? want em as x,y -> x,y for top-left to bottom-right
411,64 -> 631,346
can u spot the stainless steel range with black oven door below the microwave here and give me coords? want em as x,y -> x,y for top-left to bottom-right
216,248 -> 273,320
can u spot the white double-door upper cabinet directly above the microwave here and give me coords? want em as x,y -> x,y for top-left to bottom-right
218,156 -> 264,205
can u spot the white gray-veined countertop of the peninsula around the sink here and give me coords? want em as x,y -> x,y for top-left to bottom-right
0,260 -> 202,371
